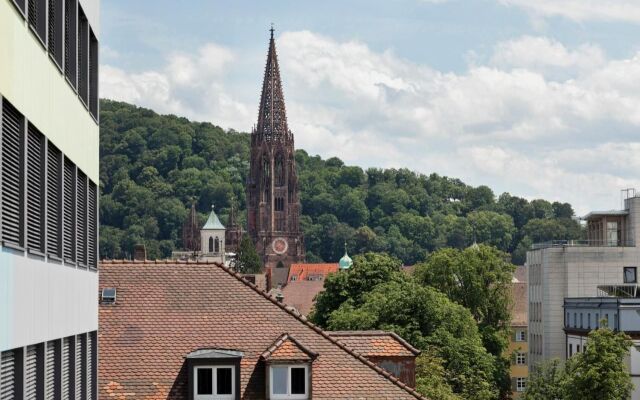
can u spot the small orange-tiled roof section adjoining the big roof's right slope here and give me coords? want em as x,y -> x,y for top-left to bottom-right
327,331 -> 420,357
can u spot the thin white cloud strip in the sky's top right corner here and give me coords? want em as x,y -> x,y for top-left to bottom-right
498,0 -> 640,23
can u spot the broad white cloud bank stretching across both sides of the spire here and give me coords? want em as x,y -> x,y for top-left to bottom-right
101,32 -> 640,213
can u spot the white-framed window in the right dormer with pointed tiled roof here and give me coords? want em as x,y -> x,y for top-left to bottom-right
269,364 -> 309,400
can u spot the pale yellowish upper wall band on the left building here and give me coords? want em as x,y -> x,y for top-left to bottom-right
0,0 -> 99,183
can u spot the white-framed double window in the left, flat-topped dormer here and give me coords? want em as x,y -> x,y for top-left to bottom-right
193,365 -> 236,400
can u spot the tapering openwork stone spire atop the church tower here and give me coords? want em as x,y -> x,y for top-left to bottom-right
254,26 -> 291,142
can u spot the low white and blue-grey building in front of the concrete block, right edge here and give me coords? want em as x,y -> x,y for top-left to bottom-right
564,296 -> 640,400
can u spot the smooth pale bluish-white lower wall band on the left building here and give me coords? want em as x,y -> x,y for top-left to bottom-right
0,247 -> 98,351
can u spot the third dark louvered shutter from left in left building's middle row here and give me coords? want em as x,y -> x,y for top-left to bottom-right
47,142 -> 62,258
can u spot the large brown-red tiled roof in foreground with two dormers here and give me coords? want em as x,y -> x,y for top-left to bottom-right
98,261 -> 423,400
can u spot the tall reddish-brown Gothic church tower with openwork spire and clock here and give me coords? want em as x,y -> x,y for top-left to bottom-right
247,28 -> 304,267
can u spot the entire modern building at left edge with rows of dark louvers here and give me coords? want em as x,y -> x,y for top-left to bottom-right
0,0 -> 100,400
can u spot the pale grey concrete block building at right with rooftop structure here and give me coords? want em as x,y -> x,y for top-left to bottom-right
526,191 -> 640,368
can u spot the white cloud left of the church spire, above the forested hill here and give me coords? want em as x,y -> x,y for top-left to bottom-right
100,43 -> 250,128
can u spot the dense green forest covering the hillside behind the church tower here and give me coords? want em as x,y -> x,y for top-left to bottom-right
100,100 -> 583,264
